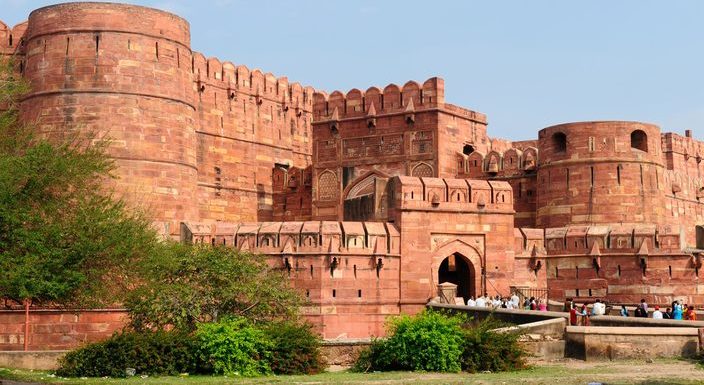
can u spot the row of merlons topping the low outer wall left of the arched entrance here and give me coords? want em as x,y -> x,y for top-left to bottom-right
181,221 -> 400,255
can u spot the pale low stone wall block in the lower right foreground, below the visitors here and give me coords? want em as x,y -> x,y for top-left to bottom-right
565,326 -> 699,361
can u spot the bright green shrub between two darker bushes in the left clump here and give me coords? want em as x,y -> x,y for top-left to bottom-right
195,318 -> 274,377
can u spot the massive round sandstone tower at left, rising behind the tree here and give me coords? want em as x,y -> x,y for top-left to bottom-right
21,3 -> 197,234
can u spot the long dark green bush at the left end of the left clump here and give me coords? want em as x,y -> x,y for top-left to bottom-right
56,332 -> 197,377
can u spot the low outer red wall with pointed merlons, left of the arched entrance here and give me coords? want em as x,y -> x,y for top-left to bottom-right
182,221 -> 401,339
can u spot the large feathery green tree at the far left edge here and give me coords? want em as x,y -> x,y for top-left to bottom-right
0,62 -> 157,306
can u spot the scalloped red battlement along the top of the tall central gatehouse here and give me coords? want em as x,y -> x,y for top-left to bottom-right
313,77 -> 456,121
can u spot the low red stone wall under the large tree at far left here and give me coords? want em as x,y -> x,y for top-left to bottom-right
0,309 -> 127,351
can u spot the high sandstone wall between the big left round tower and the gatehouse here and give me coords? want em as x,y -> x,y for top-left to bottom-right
192,53 -> 313,221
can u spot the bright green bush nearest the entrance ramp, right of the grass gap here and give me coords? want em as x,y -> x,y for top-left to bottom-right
357,311 -> 465,372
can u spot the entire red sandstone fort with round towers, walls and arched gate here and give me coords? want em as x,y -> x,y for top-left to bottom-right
0,3 -> 704,338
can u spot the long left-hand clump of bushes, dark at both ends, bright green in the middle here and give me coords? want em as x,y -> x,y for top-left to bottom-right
57,318 -> 325,377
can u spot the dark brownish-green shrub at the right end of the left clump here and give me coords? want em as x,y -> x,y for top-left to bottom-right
263,321 -> 325,374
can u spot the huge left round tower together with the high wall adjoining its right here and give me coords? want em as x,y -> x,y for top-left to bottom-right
0,3 -> 313,235
